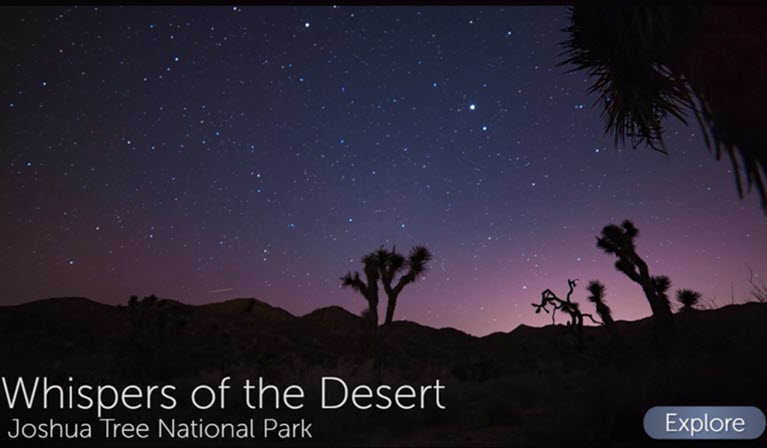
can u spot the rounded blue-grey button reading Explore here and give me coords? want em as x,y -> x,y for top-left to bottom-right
644,406 -> 765,440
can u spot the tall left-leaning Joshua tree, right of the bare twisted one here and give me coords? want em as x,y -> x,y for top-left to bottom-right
597,220 -> 672,324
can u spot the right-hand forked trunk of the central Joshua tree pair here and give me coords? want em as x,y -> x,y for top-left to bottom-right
376,246 -> 432,324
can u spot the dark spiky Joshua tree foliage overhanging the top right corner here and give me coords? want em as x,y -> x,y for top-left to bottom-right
560,3 -> 767,212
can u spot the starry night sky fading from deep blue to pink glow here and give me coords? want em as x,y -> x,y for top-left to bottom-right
0,6 -> 767,335
